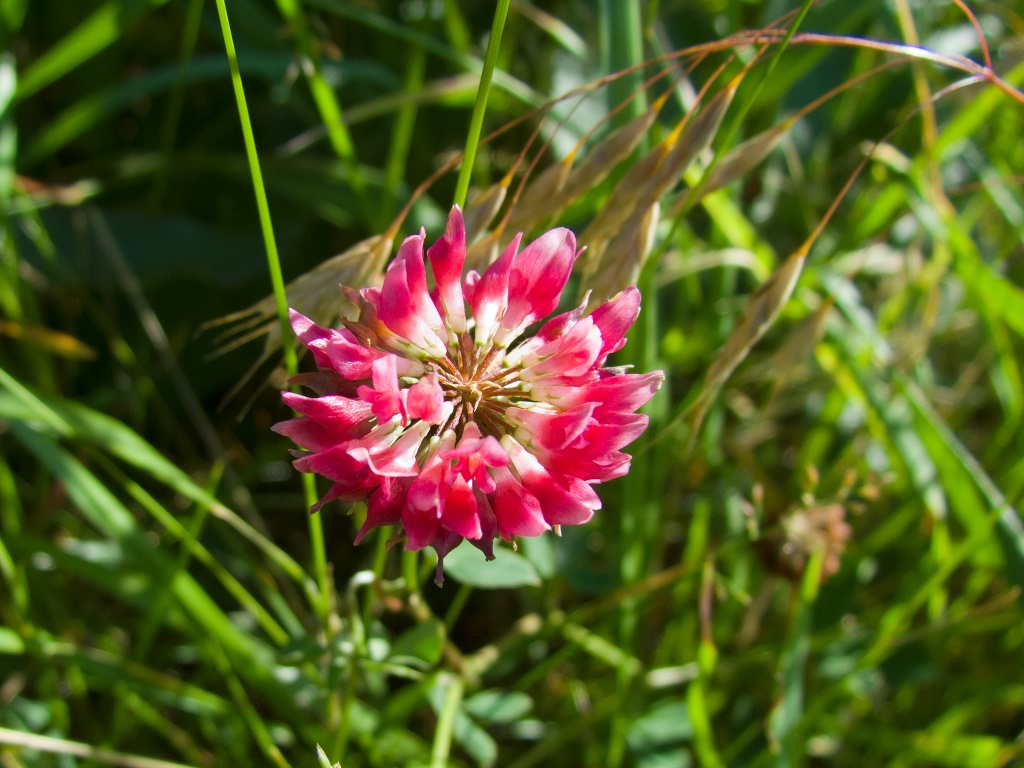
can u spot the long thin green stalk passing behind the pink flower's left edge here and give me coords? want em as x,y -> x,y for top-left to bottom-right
217,0 -> 330,631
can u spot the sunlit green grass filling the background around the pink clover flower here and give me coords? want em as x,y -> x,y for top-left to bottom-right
0,0 -> 1024,768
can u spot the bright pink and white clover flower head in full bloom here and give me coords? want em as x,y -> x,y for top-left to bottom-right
274,207 -> 664,580
